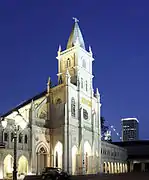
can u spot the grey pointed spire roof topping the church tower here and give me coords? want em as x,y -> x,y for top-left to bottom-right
67,18 -> 85,49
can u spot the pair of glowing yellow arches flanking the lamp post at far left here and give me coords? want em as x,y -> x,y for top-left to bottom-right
3,154 -> 28,178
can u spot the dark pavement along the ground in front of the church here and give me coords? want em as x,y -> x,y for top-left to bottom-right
24,172 -> 149,180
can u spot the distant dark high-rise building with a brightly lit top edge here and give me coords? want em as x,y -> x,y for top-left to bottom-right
121,118 -> 139,141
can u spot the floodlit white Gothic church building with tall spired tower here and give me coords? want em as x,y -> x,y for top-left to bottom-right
0,19 -> 127,178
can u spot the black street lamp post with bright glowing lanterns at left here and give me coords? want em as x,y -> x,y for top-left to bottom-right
1,111 -> 27,180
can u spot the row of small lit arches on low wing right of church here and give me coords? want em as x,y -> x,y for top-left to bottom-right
103,162 -> 128,173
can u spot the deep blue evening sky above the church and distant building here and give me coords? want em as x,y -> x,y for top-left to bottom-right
0,0 -> 149,139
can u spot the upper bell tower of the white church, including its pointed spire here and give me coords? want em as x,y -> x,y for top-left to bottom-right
57,18 -> 94,93
